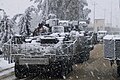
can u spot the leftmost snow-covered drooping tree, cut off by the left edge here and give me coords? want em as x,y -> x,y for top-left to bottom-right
0,9 -> 14,44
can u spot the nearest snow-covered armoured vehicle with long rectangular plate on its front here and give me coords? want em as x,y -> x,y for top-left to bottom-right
3,30 -> 80,78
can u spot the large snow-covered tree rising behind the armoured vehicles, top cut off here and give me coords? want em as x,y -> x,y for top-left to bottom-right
31,0 -> 88,20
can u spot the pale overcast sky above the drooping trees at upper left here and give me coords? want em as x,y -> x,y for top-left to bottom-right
0,0 -> 32,17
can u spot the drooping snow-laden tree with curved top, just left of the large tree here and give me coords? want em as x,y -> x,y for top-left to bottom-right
18,6 -> 37,36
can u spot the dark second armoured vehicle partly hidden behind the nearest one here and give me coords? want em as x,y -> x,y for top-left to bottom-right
77,31 -> 94,63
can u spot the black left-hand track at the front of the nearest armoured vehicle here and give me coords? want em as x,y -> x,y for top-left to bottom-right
15,63 -> 27,79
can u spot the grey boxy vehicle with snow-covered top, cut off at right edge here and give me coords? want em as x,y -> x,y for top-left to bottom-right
103,35 -> 120,76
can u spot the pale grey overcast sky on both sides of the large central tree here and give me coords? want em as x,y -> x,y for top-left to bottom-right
0,0 -> 120,25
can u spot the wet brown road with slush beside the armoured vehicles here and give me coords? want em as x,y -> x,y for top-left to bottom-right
0,44 -> 120,80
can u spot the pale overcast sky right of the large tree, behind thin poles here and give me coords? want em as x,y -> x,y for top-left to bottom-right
87,0 -> 120,26
